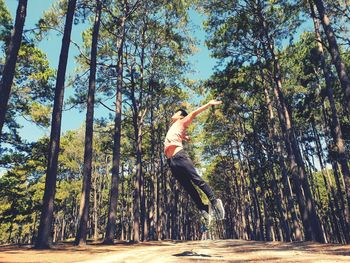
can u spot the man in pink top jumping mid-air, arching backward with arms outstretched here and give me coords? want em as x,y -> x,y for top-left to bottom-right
164,100 -> 225,220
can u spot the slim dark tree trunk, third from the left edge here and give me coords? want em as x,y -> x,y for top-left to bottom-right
75,0 -> 102,248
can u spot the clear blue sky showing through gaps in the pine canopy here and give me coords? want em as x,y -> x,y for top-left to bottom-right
5,0 -> 215,141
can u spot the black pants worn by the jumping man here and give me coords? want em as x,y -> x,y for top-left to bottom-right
168,150 -> 215,212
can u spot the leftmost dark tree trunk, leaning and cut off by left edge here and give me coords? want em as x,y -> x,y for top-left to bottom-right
0,0 -> 28,139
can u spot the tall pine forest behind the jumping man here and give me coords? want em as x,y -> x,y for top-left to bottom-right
0,0 -> 350,248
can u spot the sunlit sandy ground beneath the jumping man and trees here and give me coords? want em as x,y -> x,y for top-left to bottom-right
0,240 -> 350,263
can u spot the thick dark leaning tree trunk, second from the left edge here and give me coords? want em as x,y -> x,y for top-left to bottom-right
35,0 -> 77,248
